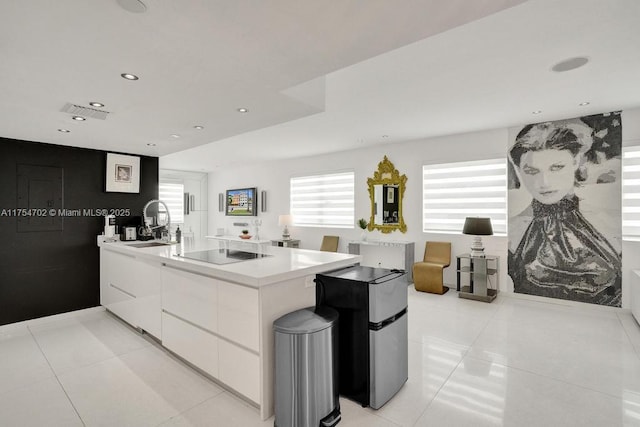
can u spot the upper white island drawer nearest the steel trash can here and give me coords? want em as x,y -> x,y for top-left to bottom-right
218,281 -> 260,351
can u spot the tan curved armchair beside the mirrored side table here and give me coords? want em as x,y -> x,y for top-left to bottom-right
413,242 -> 451,295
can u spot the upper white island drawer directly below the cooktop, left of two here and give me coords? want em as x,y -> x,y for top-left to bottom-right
162,267 -> 219,332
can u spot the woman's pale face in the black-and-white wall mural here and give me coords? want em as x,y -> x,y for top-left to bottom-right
520,149 -> 578,205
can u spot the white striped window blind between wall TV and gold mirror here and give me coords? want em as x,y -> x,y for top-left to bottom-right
290,172 -> 355,228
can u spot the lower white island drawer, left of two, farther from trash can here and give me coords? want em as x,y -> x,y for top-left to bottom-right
162,312 -> 219,378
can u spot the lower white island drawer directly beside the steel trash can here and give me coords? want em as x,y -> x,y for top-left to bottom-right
218,339 -> 260,404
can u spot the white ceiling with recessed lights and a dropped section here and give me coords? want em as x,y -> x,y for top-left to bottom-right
0,0 -> 640,174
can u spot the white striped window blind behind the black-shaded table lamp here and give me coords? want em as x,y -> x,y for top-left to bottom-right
422,158 -> 507,235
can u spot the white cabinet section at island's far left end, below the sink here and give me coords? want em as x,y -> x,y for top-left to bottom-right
100,250 -> 162,338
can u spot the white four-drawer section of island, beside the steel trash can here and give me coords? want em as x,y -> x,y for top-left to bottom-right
162,267 -> 260,403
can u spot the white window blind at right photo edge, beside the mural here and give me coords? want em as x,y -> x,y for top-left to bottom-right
622,146 -> 640,240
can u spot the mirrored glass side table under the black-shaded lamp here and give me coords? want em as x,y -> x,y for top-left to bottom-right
456,254 -> 500,302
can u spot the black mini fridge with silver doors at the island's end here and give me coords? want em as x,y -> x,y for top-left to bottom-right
316,266 -> 409,409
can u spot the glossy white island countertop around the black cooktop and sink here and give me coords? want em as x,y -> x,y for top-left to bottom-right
98,236 -> 361,288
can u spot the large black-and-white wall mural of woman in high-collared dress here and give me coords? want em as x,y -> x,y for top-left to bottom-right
508,112 -> 622,307
